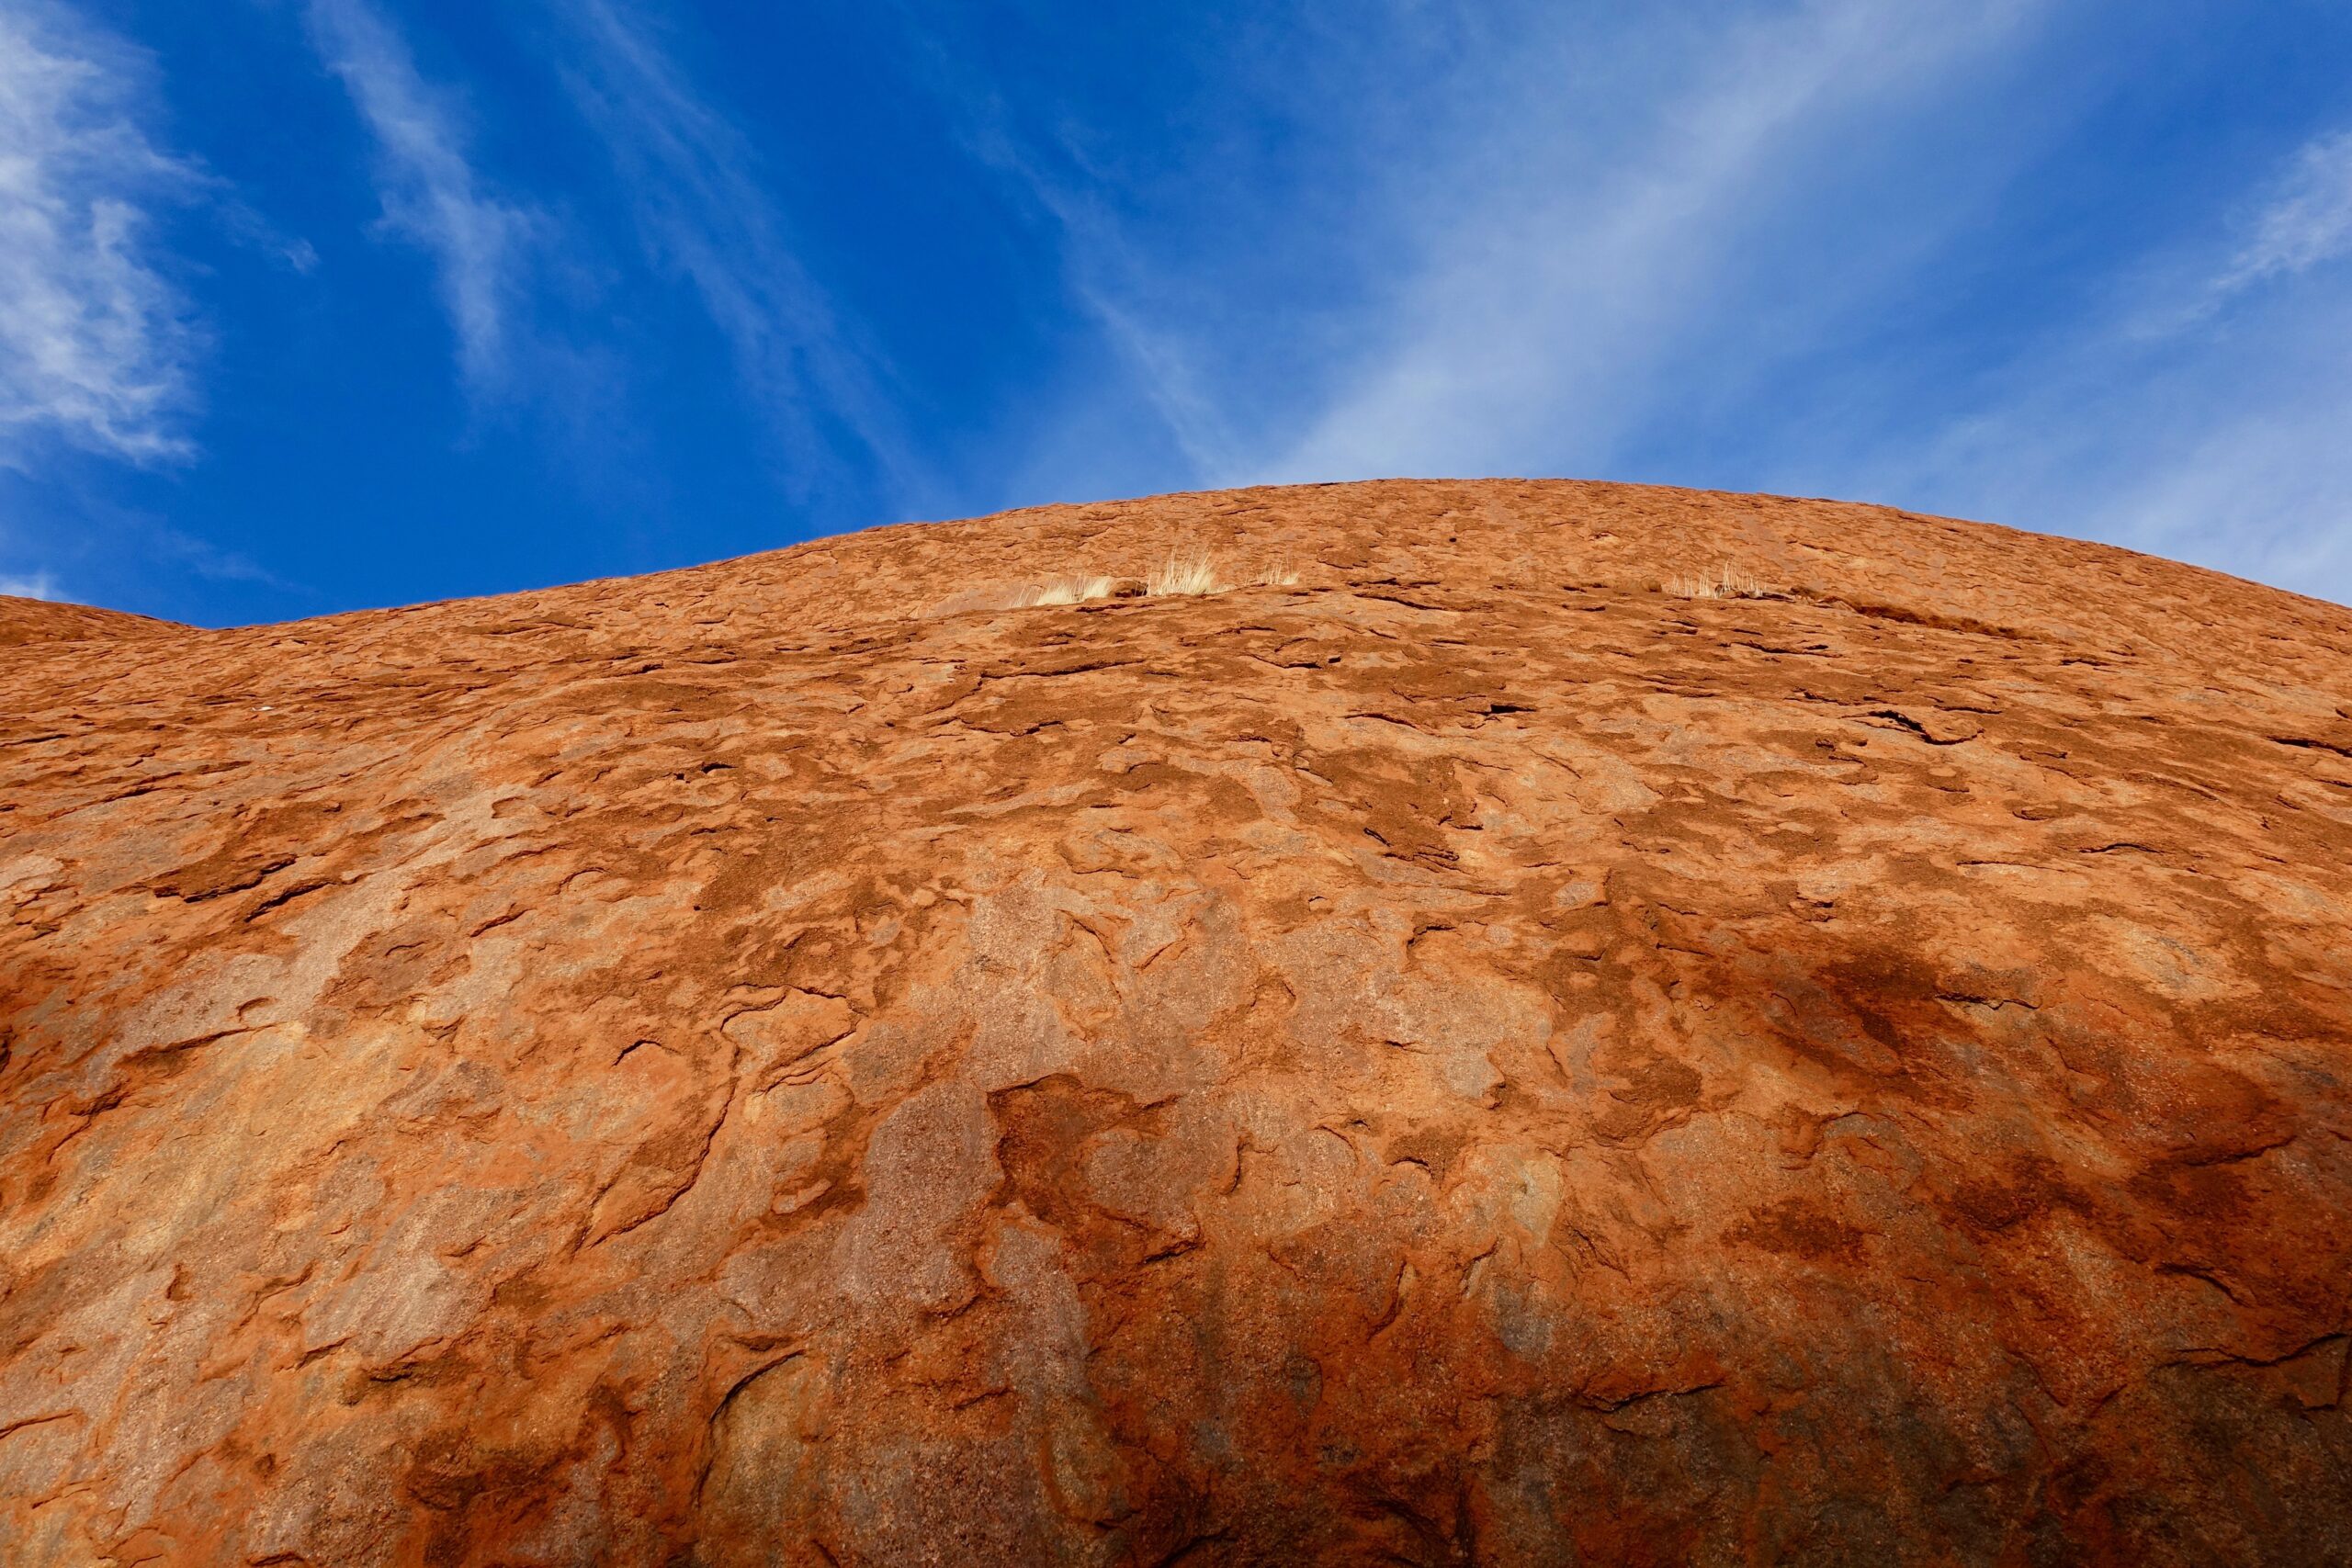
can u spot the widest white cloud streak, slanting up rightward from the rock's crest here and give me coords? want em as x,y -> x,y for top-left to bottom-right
1253,0 -> 2046,479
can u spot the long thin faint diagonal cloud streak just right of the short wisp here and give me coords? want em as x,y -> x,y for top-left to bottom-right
553,0 -> 924,493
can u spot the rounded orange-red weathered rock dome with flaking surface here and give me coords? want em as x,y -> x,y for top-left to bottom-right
0,482 -> 2352,1568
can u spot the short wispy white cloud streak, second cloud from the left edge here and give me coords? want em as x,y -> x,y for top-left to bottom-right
306,0 -> 543,395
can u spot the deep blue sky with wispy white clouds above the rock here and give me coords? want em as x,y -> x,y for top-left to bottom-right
0,0 -> 2352,626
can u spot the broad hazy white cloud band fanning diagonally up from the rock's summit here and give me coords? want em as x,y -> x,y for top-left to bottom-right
1251,0 -> 2037,479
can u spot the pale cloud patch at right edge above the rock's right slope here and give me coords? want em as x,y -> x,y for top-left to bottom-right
1865,115 -> 2352,604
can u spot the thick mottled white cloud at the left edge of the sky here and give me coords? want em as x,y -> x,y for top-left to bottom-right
0,0 -> 202,468
